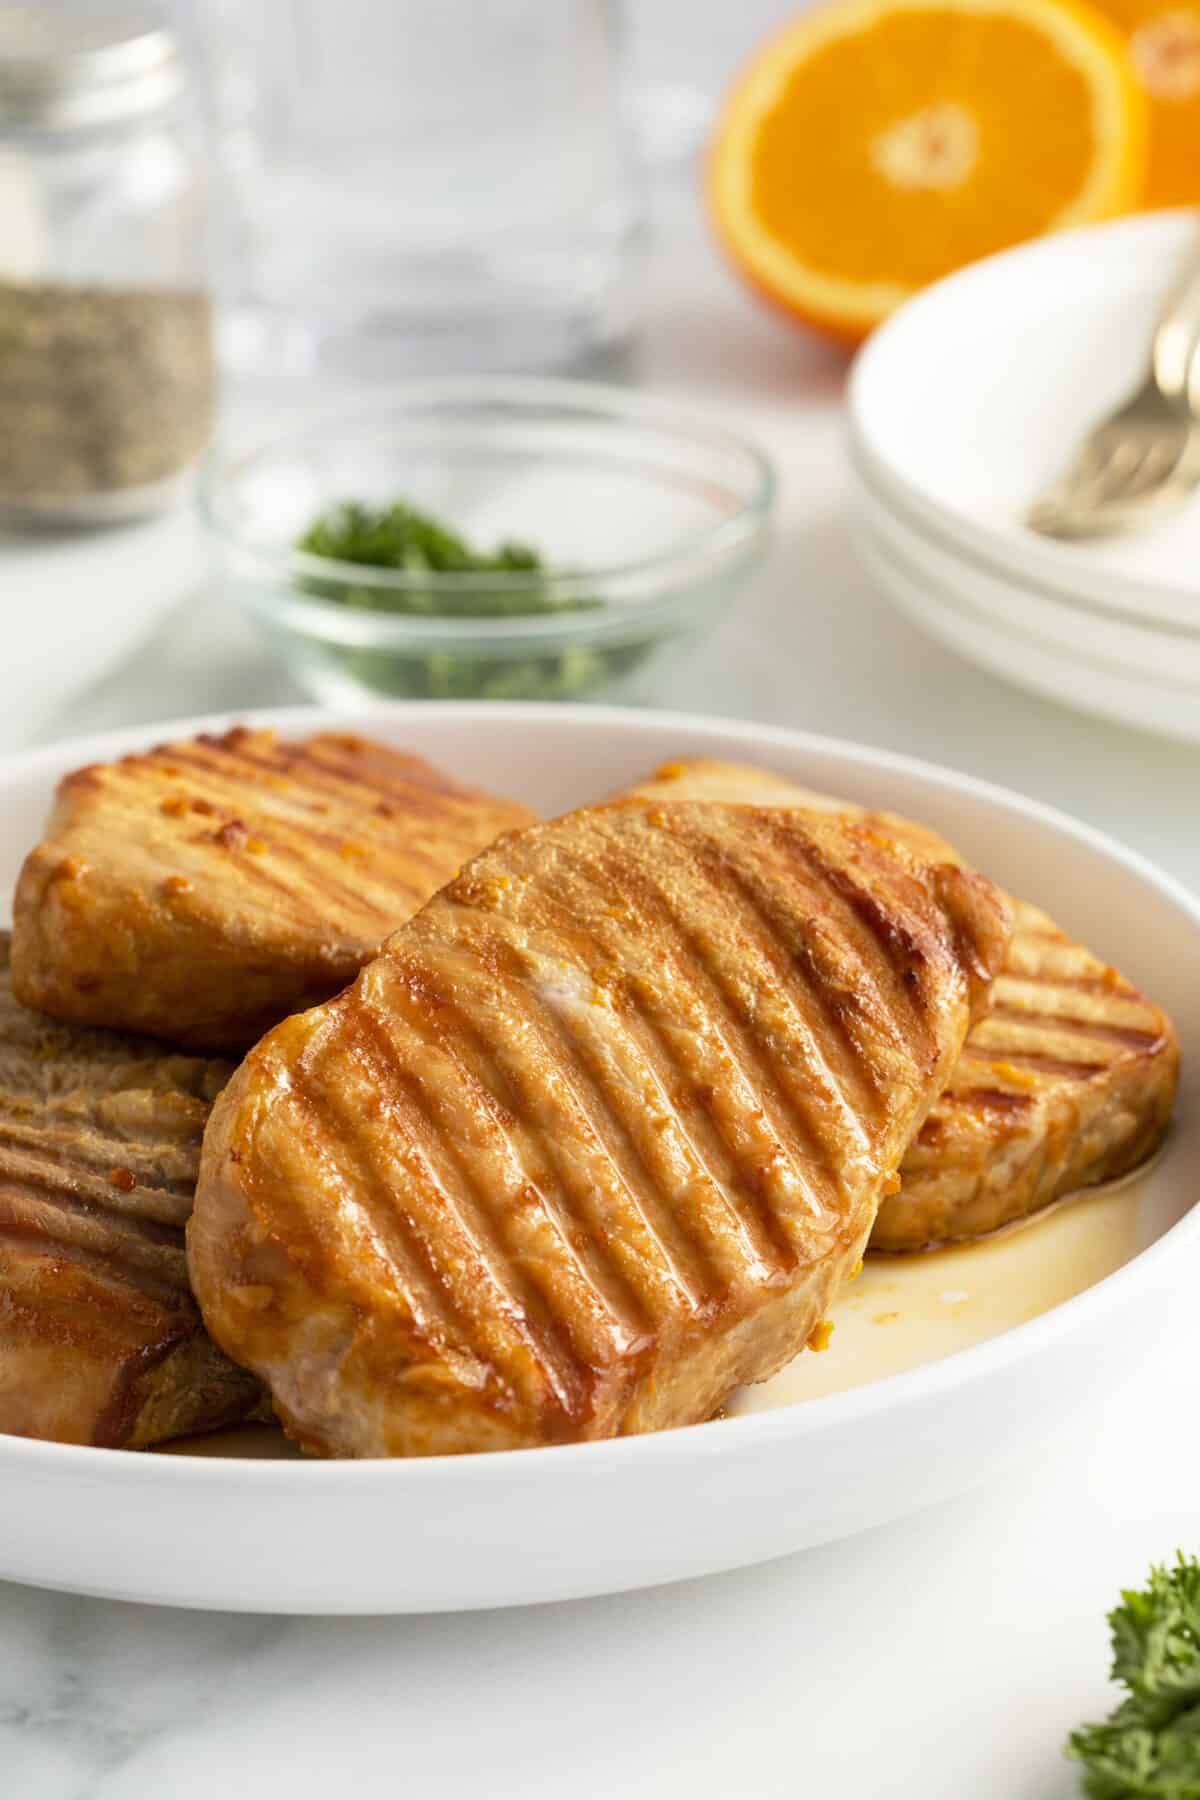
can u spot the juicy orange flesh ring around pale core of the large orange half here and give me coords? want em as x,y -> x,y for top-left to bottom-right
752,11 -> 1094,286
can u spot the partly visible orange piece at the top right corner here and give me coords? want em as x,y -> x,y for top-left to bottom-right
1099,0 -> 1200,207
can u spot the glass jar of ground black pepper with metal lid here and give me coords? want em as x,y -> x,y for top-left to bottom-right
0,4 -> 214,524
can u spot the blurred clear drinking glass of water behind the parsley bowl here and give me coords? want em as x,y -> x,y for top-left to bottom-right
194,0 -> 640,378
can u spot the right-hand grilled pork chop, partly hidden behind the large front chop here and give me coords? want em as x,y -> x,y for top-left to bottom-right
621,758 -> 1178,1251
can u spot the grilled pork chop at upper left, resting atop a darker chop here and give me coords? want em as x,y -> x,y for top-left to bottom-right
13,727 -> 533,1051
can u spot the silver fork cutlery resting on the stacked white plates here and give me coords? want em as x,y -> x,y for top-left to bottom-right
1025,223 -> 1200,538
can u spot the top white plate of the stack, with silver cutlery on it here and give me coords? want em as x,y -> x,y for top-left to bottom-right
849,212 -> 1200,641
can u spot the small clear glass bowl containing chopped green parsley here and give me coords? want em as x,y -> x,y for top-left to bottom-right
200,378 -> 775,704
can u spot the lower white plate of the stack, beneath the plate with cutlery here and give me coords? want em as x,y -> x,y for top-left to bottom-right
851,472 -> 1200,742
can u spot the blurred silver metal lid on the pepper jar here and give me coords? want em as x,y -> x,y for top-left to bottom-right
0,4 -> 184,131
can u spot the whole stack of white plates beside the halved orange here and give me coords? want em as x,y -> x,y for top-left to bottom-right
849,212 -> 1200,740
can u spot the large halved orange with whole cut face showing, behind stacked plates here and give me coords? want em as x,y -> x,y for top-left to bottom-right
709,0 -> 1146,342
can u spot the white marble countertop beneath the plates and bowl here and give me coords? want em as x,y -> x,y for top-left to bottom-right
0,189 -> 1200,1800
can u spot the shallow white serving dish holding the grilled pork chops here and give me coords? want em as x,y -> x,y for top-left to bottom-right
0,704 -> 1200,1613
